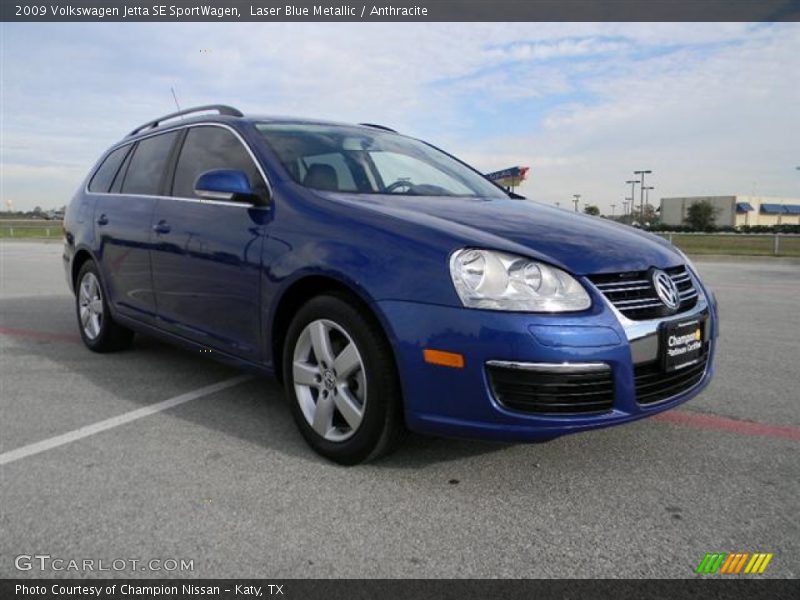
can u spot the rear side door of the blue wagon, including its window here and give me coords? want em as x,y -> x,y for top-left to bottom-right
90,131 -> 179,322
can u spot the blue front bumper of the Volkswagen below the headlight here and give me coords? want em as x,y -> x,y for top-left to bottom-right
380,301 -> 715,441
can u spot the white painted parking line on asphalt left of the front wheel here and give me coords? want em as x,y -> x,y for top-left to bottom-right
0,375 -> 252,465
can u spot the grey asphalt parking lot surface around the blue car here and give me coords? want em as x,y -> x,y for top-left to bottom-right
0,242 -> 800,578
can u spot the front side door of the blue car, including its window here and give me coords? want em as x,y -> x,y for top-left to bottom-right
152,125 -> 271,360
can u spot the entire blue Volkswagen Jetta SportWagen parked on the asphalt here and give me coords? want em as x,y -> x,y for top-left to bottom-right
64,106 -> 717,464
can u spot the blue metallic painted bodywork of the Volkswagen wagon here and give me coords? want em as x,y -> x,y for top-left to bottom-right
64,117 -> 717,441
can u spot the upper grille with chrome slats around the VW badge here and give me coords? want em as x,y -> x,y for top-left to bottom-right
589,265 -> 697,321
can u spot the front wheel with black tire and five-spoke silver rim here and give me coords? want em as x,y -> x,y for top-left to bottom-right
283,295 -> 405,465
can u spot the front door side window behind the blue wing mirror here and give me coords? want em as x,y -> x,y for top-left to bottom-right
172,126 -> 266,198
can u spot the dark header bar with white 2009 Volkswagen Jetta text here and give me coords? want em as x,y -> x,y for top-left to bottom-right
0,0 -> 800,22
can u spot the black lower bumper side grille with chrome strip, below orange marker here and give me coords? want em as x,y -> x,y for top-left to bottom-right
486,365 -> 614,414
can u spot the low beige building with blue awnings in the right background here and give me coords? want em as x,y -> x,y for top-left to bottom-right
661,196 -> 800,227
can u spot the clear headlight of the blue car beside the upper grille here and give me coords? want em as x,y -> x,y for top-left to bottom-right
450,248 -> 592,312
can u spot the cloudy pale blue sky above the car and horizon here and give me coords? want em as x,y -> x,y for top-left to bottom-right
0,23 -> 800,212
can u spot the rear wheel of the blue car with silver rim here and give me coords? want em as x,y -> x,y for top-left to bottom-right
75,260 -> 133,352
